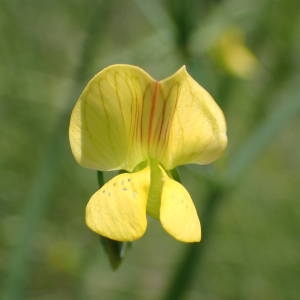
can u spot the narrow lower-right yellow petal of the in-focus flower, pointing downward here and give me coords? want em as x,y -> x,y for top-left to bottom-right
160,166 -> 201,243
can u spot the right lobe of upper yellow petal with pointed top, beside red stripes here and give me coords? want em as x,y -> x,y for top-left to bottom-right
159,67 -> 227,170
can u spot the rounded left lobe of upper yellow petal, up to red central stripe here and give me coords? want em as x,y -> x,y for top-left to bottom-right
69,65 -> 155,171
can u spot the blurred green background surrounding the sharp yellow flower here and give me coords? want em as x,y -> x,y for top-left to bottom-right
0,0 -> 300,300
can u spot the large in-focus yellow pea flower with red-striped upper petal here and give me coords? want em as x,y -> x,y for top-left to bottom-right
69,65 -> 227,242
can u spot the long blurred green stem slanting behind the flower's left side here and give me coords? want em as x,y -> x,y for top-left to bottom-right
1,1 -> 109,300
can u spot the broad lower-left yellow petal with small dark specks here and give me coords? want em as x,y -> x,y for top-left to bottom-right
86,167 -> 150,241
